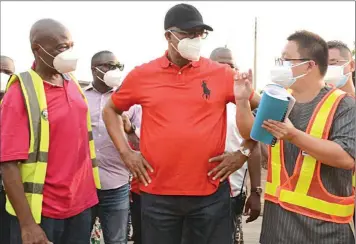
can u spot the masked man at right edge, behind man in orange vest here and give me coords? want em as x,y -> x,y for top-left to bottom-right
324,41 -> 355,96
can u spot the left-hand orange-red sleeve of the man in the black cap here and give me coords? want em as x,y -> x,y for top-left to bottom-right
111,69 -> 140,111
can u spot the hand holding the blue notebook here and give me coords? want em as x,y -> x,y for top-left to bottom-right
262,118 -> 298,141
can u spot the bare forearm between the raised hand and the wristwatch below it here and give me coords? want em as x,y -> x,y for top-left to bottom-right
236,100 -> 254,139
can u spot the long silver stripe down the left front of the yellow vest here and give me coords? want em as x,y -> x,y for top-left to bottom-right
19,72 -> 41,163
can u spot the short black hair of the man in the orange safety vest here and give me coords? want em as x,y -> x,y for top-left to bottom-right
287,30 -> 329,76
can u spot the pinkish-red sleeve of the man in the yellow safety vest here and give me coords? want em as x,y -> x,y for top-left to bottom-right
0,82 -> 30,162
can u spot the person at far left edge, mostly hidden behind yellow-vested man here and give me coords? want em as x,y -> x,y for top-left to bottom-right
0,56 -> 15,243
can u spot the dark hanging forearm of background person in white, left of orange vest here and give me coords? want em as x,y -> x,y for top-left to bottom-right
247,143 -> 262,189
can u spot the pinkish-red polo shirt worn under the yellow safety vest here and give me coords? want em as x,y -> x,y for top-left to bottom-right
0,73 -> 98,219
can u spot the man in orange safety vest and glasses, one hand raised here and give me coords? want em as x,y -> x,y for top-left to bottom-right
236,31 -> 356,244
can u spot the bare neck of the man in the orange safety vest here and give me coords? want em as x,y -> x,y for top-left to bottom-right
292,78 -> 325,103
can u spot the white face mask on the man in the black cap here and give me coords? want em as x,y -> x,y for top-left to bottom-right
169,31 -> 202,61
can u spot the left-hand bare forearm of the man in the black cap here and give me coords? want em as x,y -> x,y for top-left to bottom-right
103,101 -> 132,155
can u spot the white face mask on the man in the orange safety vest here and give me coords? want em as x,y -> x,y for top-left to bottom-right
271,61 -> 309,89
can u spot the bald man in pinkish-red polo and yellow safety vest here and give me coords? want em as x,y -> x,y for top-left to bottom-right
0,19 -> 100,244
